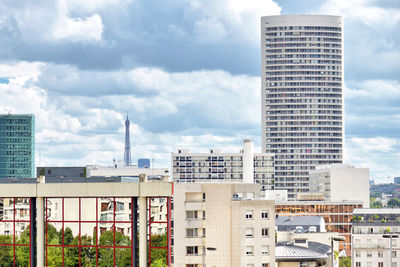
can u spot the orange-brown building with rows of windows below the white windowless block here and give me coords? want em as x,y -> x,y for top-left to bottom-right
275,201 -> 363,255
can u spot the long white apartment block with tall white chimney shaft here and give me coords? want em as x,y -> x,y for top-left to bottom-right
171,139 -> 275,190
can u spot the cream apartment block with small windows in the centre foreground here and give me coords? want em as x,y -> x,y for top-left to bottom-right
173,183 -> 275,267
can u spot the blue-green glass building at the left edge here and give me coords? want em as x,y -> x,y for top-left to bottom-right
0,114 -> 35,178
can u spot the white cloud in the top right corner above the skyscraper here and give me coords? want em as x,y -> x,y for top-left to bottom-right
320,0 -> 400,28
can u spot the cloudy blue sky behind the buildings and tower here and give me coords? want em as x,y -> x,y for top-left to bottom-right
0,0 -> 400,182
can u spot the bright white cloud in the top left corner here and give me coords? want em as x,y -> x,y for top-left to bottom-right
0,0 -> 104,45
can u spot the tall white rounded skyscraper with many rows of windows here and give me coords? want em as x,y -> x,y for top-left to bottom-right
261,15 -> 344,200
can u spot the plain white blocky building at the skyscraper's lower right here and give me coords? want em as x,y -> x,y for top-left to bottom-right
299,164 -> 369,208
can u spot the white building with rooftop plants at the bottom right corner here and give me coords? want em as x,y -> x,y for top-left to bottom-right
351,209 -> 400,267
